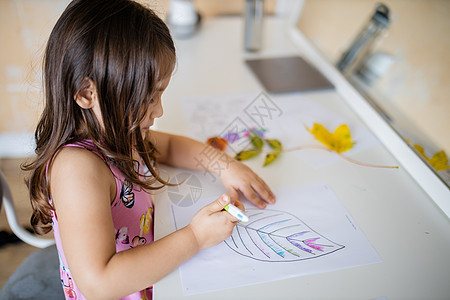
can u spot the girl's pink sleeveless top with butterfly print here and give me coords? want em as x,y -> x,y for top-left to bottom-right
52,140 -> 154,300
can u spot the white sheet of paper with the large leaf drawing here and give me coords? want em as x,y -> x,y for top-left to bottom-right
170,183 -> 381,295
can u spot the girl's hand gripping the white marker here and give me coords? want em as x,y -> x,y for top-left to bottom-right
187,194 -> 244,250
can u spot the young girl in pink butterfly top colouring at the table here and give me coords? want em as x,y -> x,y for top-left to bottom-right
25,0 -> 275,299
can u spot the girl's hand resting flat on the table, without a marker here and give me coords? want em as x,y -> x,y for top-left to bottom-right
220,160 -> 275,208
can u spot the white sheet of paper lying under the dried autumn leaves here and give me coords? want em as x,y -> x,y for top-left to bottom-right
182,93 -> 379,168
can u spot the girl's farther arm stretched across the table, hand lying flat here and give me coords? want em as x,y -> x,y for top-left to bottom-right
146,130 -> 275,208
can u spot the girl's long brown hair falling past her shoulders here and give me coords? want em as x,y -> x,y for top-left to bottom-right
23,0 -> 175,234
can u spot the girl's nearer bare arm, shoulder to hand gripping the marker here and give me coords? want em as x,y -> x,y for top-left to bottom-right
49,148 -> 237,299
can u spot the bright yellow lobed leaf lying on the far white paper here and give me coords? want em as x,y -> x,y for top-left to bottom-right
306,123 -> 355,153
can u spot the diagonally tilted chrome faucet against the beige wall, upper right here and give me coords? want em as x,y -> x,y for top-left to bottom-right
337,4 -> 389,74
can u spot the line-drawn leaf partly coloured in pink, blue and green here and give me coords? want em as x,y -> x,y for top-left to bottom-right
225,209 -> 345,262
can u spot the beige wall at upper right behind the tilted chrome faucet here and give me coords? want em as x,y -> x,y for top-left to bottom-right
298,0 -> 450,154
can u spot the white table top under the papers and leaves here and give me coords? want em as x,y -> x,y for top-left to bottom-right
154,17 -> 450,300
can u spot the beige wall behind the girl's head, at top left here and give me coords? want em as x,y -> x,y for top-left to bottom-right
0,0 -> 275,141
